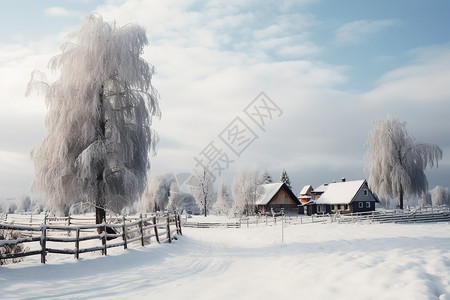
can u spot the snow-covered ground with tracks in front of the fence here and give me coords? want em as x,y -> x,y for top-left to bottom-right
0,219 -> 450,300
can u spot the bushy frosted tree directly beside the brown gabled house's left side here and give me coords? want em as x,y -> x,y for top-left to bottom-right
231,168 -> 259,216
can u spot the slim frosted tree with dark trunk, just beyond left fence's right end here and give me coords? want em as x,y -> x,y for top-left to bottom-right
190,167 -> 214,217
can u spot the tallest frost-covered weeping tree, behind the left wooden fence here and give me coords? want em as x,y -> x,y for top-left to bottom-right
27,14 -> 159,223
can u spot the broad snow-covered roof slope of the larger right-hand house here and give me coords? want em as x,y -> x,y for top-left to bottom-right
316,179 -> 365,204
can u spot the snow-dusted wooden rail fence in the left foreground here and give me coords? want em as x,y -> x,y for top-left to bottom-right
0,215 -> 182,263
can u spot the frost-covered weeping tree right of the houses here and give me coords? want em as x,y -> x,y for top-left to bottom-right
366,116 -> 442,209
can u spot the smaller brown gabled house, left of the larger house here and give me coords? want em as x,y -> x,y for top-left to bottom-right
256,182 -> 303,214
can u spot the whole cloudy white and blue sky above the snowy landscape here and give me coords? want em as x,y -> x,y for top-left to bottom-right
0,0 -> 450,199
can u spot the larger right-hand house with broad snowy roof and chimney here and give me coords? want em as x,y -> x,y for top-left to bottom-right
304,179 -> 380,215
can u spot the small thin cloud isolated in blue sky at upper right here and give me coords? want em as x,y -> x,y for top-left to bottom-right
335,19 -> 398,44
